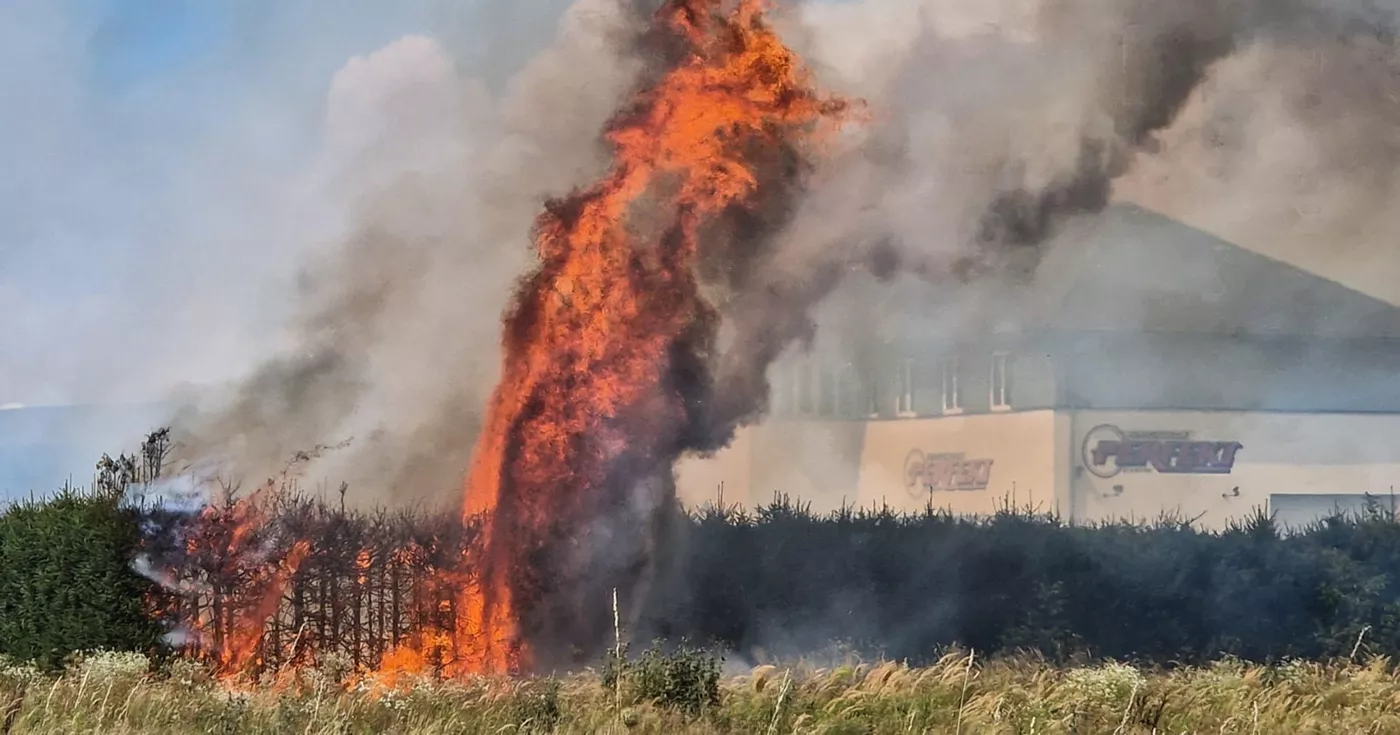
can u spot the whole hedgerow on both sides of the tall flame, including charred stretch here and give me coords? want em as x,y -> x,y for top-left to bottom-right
8,435 -> 1400,671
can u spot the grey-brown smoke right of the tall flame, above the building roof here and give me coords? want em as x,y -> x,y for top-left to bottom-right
688,0 -> 1397,434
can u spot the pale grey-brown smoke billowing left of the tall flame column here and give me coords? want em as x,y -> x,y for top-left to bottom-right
170,0 -> 649,501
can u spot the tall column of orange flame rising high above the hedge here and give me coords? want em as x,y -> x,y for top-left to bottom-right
461,0 -> 846,672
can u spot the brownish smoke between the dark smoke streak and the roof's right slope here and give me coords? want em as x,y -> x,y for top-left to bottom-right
1119,20 -> 1400,302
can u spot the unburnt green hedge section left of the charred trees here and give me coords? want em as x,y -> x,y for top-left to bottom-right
0,489 -> 164,666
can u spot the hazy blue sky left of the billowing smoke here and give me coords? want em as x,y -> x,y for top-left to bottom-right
0,0 -> 579,406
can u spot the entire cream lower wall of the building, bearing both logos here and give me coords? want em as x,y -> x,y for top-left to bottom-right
678,410 -> 1400,529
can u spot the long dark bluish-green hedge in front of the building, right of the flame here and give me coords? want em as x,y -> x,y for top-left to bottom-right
650,498 -> 1400,664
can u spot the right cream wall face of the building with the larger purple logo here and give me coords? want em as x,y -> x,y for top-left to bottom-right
1072,412 -> 1400,529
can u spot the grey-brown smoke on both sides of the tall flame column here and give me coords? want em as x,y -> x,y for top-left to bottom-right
150,0 -> 1393,515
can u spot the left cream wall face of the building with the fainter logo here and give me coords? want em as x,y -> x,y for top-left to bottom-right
676,410 -> 1052,514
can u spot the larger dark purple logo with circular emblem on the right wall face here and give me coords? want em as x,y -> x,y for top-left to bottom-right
1084,424 -> 1245,479
